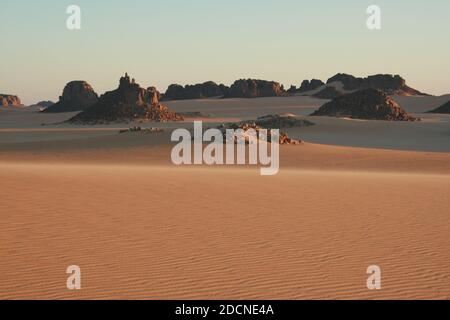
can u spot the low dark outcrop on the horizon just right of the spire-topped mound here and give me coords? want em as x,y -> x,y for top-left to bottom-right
163,81 -> 229,100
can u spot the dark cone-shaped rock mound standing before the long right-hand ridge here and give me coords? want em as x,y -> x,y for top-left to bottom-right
312,89 -> 417,121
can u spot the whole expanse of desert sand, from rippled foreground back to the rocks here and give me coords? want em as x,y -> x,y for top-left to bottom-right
0,97 -> 450,299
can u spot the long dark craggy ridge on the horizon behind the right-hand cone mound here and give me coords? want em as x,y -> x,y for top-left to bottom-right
327,73 -> 427,96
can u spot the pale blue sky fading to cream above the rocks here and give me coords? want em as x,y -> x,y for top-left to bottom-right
0,0 -> 450,103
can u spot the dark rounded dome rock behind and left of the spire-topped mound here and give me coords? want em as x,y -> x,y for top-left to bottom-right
43,81 -> 98,113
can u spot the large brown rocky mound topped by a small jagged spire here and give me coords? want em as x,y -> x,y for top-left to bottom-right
69,74 -> 183,124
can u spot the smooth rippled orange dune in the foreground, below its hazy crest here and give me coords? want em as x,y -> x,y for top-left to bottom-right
0,164 -> 450,299
